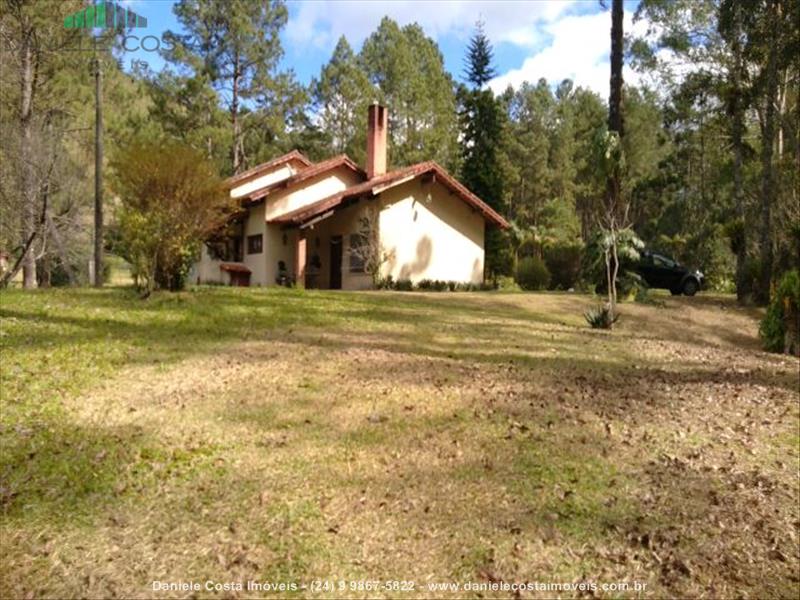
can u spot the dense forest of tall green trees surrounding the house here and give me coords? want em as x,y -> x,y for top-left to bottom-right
0,0 -> 800,302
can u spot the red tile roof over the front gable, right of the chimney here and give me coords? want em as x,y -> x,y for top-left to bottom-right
269,161 -> 509,229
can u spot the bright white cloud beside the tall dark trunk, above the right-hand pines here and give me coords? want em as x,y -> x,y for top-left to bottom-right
489,11 -> 646,98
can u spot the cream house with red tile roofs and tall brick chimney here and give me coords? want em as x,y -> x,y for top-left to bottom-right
191,104 -> 508,289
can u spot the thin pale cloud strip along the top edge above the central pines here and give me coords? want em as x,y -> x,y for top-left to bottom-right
286,0 -> 576,49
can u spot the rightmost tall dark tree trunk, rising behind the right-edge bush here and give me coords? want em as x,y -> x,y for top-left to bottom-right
757,0 -> 779,303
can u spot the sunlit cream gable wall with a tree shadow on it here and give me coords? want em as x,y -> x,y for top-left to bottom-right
380,179 -> 485,283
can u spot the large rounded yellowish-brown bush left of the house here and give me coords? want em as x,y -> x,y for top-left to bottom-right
111,141 -> 234,295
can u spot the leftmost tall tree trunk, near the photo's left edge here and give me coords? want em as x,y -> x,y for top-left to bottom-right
20,21 -> 36,289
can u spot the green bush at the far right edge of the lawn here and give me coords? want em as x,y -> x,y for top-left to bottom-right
759,270 -> 800,356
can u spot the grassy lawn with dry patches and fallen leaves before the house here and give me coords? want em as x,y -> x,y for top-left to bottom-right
0,288 -> 800,597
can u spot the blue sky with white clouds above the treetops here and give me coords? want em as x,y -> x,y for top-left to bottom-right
122,0 -> 642,96
